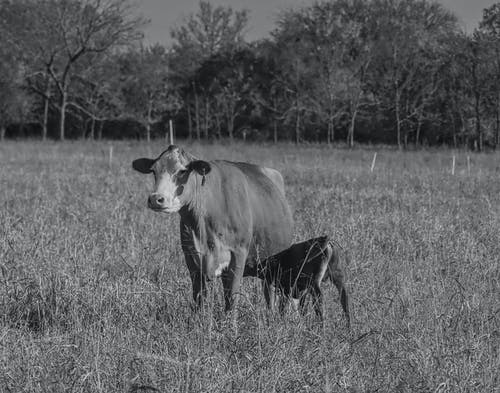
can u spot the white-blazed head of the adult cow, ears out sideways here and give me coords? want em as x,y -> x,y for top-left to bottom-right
132,145 -> 211,213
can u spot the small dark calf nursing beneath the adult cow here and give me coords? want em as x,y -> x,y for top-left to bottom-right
255,236 -> 350,327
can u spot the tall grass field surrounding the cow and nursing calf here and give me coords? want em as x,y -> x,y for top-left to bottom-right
0,141 -> 500,393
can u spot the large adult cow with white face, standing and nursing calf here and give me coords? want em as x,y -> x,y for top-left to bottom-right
132,145 -> 293,311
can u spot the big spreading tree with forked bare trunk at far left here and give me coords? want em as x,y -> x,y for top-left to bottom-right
1,0 -> 144,139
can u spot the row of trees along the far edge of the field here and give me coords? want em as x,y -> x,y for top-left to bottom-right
0,0 -> 500,150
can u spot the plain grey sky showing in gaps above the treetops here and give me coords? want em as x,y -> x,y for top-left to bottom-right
139,0 -> 496,44
